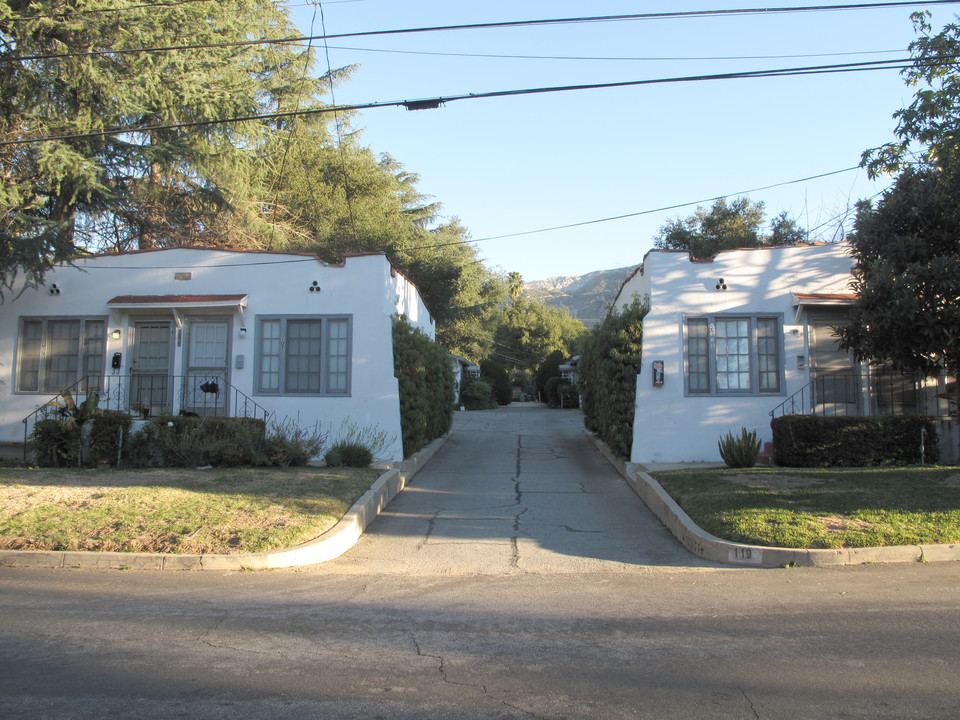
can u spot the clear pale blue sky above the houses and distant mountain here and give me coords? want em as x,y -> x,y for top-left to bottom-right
290,0 -> 960,281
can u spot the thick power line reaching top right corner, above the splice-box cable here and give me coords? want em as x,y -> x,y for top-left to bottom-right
0,0 -> 960,62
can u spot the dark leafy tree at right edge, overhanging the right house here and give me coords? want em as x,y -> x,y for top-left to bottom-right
837,13 -> 960,404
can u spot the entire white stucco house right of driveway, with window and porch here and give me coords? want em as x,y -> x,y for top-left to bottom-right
614,243 -> 955,463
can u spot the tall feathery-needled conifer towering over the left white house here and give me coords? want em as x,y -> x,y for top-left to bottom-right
0,0 -> 315,296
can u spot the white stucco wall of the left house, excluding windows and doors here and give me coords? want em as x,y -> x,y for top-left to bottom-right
0,248 -> 435,460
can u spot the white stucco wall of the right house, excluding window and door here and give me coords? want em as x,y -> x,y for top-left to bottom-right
615,243 -> 853,463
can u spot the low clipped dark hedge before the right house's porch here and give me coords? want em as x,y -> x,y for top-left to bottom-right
770,415 -> 940,467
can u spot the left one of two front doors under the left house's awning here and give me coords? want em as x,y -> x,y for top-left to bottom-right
129,321 -> 172,417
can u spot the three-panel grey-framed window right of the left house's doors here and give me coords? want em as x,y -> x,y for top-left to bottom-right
257,315 -> 351,395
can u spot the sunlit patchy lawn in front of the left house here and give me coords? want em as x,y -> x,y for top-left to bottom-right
0,466 -> 380,554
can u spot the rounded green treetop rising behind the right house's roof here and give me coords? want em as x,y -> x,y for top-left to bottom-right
654,198 -> 806,260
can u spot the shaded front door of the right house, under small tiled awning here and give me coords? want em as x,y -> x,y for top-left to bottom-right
810,315 -> 860,415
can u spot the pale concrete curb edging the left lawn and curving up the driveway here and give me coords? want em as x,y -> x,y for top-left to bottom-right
0,433 -> 450,570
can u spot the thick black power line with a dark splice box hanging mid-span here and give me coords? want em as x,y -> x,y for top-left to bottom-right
0,55 -> 928,147
